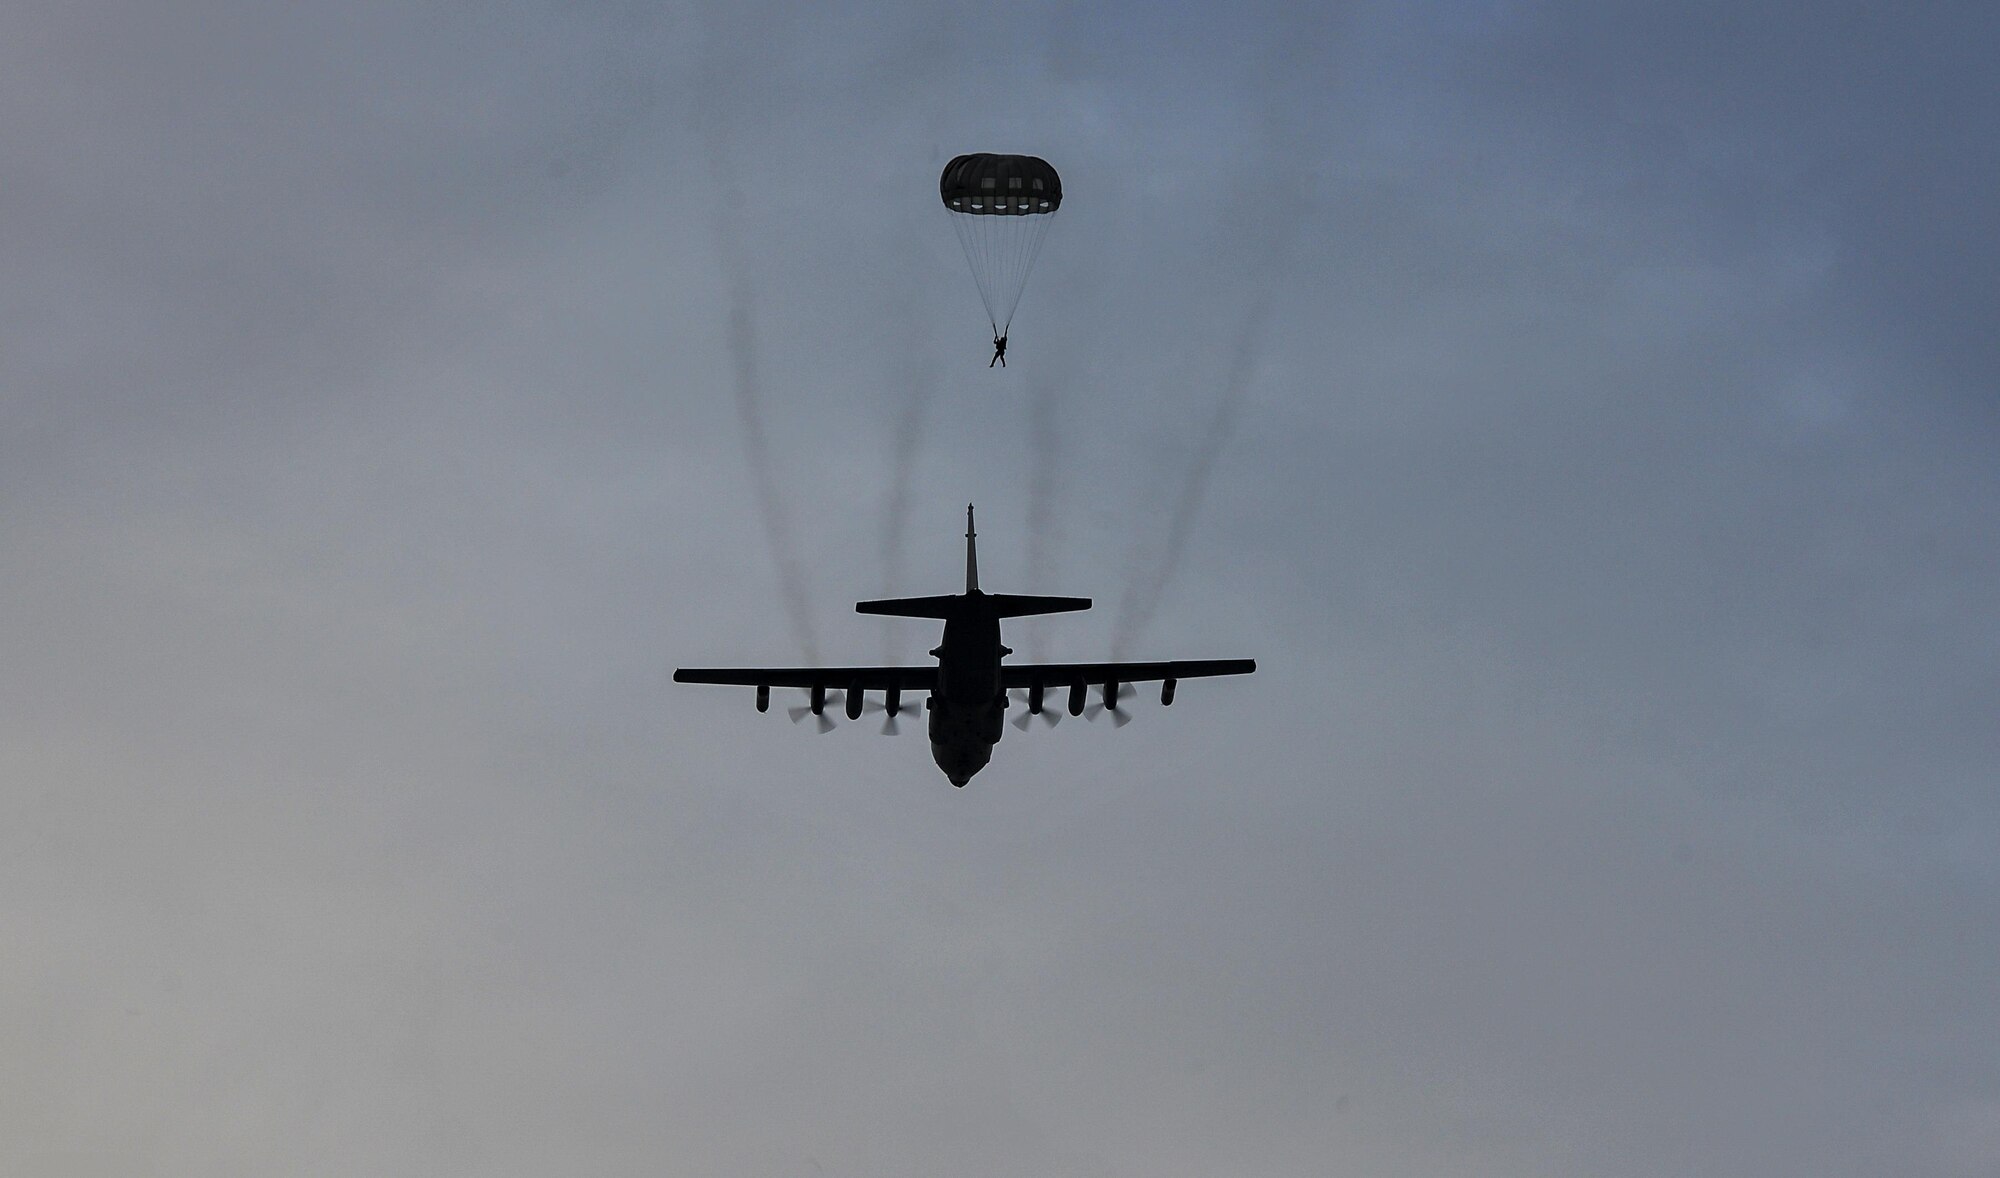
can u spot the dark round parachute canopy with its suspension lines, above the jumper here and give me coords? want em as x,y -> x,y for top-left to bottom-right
938,154 -> 1062,340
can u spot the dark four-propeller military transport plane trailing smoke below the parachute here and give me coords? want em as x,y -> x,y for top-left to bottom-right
674,506 -> 1256,786
